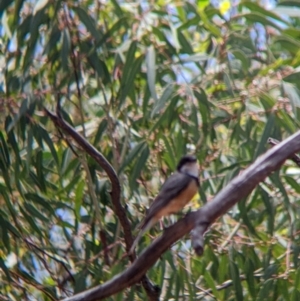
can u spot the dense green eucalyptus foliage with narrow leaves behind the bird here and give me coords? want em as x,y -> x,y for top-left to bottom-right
0,0 -> 300,300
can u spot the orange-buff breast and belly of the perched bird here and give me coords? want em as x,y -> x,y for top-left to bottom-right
157,180 -> 198,218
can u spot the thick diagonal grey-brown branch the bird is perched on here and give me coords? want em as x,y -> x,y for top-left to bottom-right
63,131 -> 300,301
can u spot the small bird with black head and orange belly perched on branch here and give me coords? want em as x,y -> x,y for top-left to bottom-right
129,155 -> 200,254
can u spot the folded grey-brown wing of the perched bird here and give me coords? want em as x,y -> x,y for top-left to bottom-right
141,172 -> 191,229
